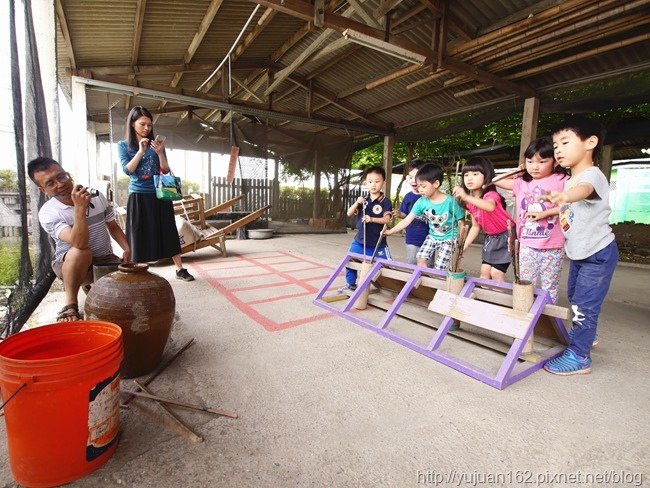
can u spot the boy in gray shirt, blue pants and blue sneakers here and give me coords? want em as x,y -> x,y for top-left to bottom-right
544,117 -> 618,376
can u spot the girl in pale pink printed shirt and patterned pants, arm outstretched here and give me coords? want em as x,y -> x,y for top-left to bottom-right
496,137 -> 567,303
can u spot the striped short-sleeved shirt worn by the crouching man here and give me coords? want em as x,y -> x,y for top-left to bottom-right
38,195 -> 115,260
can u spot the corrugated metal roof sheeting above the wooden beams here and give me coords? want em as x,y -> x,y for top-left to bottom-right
57,0 -> 650,153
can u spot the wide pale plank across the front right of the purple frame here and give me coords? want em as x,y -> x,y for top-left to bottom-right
429,290 -> 534,339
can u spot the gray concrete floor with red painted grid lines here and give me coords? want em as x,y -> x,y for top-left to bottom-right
0,232 -> 650,488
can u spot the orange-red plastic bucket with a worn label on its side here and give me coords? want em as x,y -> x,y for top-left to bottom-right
0,321 -> 123,487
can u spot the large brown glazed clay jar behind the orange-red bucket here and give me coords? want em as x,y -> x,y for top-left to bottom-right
84,263 -> 176,378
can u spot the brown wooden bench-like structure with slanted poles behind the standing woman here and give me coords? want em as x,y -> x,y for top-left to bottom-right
174,194 -> 271,256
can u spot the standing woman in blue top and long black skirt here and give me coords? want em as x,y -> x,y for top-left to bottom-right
117,107 -> 194,281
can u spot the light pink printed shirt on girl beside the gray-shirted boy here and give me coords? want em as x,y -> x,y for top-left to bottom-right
512,173 -> 566,249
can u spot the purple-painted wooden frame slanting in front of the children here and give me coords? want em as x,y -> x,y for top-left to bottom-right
314,253 -> 569,390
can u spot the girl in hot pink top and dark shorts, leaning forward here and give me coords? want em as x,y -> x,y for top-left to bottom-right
453,157 -> 512,281
